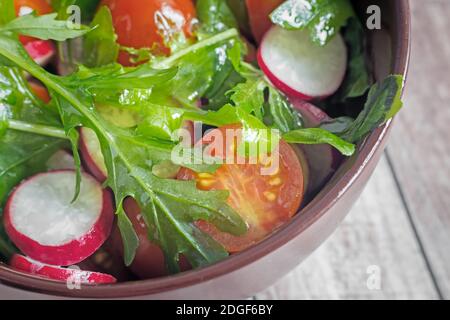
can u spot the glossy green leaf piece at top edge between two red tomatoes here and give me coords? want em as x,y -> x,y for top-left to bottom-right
196,0 -> 238,34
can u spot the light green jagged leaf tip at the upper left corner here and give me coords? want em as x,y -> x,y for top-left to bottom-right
0,13 -> 91,41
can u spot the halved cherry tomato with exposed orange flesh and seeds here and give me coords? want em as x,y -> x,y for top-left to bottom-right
178,126 -> 304,253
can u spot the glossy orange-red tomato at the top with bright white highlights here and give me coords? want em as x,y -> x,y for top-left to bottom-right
101,0 -> 196,65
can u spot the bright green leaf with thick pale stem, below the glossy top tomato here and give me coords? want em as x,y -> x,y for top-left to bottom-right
88,29 -> 238,109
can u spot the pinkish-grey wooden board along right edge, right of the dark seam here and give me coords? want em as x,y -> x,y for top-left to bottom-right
388,0 -> 450,299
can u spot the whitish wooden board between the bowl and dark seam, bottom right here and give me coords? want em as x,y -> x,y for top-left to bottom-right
256,157 -> 438,299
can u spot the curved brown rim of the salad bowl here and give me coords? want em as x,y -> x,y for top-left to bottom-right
0,0 -> 411,298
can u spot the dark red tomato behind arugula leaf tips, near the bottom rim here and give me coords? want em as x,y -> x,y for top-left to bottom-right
108,198 -> 191,279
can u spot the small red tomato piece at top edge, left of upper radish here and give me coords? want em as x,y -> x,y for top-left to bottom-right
246,0 -> 284,43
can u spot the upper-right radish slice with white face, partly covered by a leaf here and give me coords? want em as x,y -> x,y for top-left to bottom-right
258,26 -> 347,100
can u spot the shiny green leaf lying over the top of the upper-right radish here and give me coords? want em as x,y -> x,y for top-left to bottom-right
270,0 -> 355,46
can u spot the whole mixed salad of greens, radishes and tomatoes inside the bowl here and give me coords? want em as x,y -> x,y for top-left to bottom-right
0,0 -> 403,286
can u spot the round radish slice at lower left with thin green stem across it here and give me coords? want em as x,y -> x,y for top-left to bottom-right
4,170 -> 114,266
